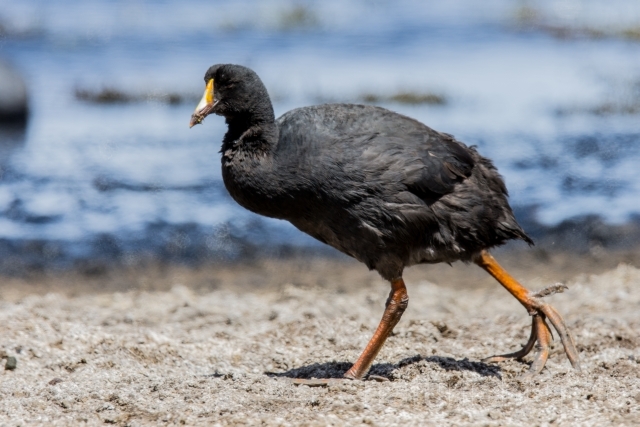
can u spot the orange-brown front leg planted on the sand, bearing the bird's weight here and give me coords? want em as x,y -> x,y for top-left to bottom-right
344,278 -> 409,379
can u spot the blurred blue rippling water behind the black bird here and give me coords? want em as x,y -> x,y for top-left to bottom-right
0,0 -> 640,273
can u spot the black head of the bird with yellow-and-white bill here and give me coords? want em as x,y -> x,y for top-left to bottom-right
189,64 -> 272,127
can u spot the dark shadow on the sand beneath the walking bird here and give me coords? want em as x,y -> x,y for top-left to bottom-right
265,355 -> 502,381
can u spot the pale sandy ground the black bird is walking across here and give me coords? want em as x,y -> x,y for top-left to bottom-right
0,254 -> 640,426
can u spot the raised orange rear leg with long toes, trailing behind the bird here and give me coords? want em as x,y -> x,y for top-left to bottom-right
475,251 -> 580,376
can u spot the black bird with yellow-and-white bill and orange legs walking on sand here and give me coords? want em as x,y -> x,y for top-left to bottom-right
190,64 -> 580,379
